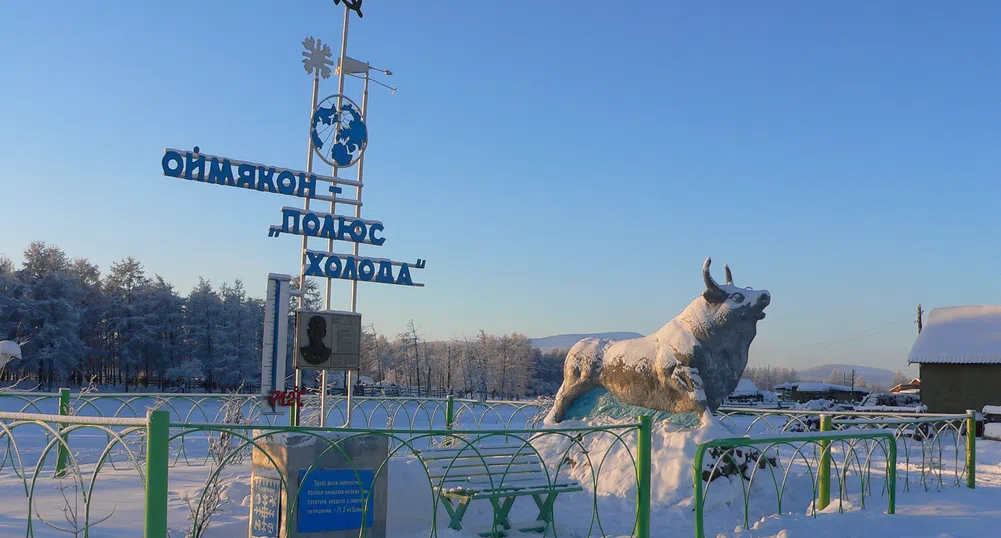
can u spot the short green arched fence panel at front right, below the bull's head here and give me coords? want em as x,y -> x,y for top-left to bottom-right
693,428 -> 897,538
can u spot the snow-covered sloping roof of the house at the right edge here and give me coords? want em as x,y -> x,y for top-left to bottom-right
907,305 -> 1001,365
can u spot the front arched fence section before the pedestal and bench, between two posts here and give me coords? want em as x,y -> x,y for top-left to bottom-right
170,418 -> 651,537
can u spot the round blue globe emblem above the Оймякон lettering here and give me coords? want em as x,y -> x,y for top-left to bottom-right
309,95 -> 368,167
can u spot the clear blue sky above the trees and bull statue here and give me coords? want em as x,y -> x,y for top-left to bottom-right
0,0 -> 1001,369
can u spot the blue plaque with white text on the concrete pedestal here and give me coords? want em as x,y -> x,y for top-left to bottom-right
296,469 -> 375,532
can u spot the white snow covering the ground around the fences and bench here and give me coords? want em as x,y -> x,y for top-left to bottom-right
0,400 -> 1001,538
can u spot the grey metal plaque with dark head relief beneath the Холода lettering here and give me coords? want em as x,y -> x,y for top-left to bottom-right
295,311 -> 361,371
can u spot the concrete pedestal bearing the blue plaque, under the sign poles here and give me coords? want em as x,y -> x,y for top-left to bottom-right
249,433 -> 389,538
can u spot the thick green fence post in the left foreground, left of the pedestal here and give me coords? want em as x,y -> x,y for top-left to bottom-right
143,411 -> 170,538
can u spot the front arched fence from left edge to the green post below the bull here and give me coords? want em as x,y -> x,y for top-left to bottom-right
0,411 -> 651,538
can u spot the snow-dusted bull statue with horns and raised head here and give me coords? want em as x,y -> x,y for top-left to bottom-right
549,257 -> 771,422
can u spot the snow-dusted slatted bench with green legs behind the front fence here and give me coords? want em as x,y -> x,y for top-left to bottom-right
419,444 -> 584,537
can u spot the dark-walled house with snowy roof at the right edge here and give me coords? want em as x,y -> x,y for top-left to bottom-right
907,305 -> 1001,413
